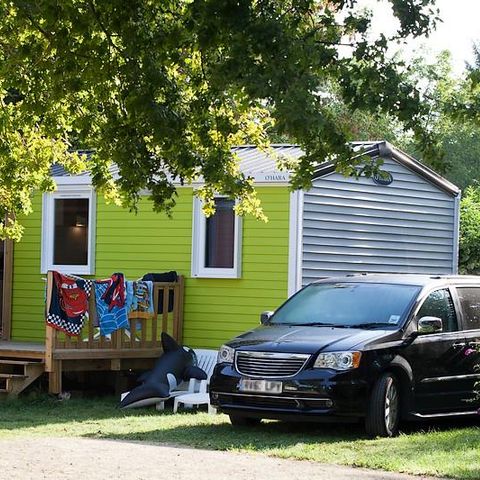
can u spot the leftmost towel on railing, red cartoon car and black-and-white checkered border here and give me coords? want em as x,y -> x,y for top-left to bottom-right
46,272 -> 92,336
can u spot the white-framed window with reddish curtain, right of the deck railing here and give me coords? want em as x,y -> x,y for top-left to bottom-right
192,197 -> 242,278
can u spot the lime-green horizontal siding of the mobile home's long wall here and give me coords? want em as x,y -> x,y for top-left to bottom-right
12,187 -> 289,348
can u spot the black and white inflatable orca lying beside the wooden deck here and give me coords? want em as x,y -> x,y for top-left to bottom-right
120,332 -> 207,408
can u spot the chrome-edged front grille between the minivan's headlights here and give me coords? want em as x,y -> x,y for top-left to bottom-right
235,351 -> 310,378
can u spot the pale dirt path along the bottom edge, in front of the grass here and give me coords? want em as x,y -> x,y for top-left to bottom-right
0,437 -> 444,480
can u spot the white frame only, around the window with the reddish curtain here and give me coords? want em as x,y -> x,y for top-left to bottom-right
192,195 -> 242,278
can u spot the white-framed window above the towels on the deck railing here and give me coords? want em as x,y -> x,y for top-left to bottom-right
42,185 -> 95,275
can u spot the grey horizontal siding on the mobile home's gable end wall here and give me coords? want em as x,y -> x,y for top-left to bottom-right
302,160 -> 456,285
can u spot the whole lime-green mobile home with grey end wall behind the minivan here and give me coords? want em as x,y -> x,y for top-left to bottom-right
2,142 -> 459,394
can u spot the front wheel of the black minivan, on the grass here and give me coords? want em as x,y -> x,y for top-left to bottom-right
365,373 -> 400,437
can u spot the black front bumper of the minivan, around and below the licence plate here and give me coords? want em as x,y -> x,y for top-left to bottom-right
210,364 -> 369,421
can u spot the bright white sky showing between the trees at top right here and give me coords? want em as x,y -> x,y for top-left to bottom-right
359,0 -> 480,74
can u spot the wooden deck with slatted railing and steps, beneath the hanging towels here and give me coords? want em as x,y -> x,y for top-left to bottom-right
0,272 -> 184,394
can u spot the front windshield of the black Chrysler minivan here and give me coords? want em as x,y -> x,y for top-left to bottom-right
270,282 -> 420,328
